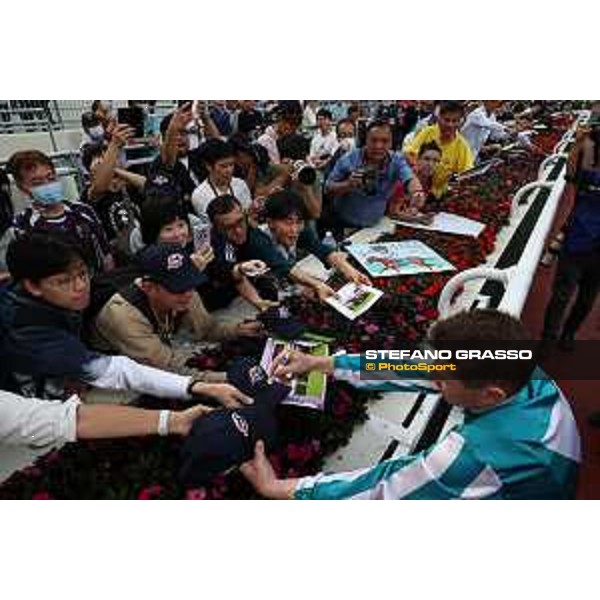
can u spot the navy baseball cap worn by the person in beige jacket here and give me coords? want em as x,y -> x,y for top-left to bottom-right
139,244 -> 206,294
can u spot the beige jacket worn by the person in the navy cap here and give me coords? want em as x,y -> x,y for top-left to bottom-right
91,293 -> 237,382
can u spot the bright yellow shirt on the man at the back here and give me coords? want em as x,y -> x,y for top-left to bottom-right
405,125 -> 474,198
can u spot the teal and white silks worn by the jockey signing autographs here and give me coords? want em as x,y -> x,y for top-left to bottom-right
295,355 -> 581,500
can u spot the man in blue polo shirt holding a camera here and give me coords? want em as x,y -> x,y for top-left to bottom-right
326,120 -> 423,227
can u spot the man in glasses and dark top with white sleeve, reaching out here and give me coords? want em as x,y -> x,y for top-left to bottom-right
0,234 -> 251,406
